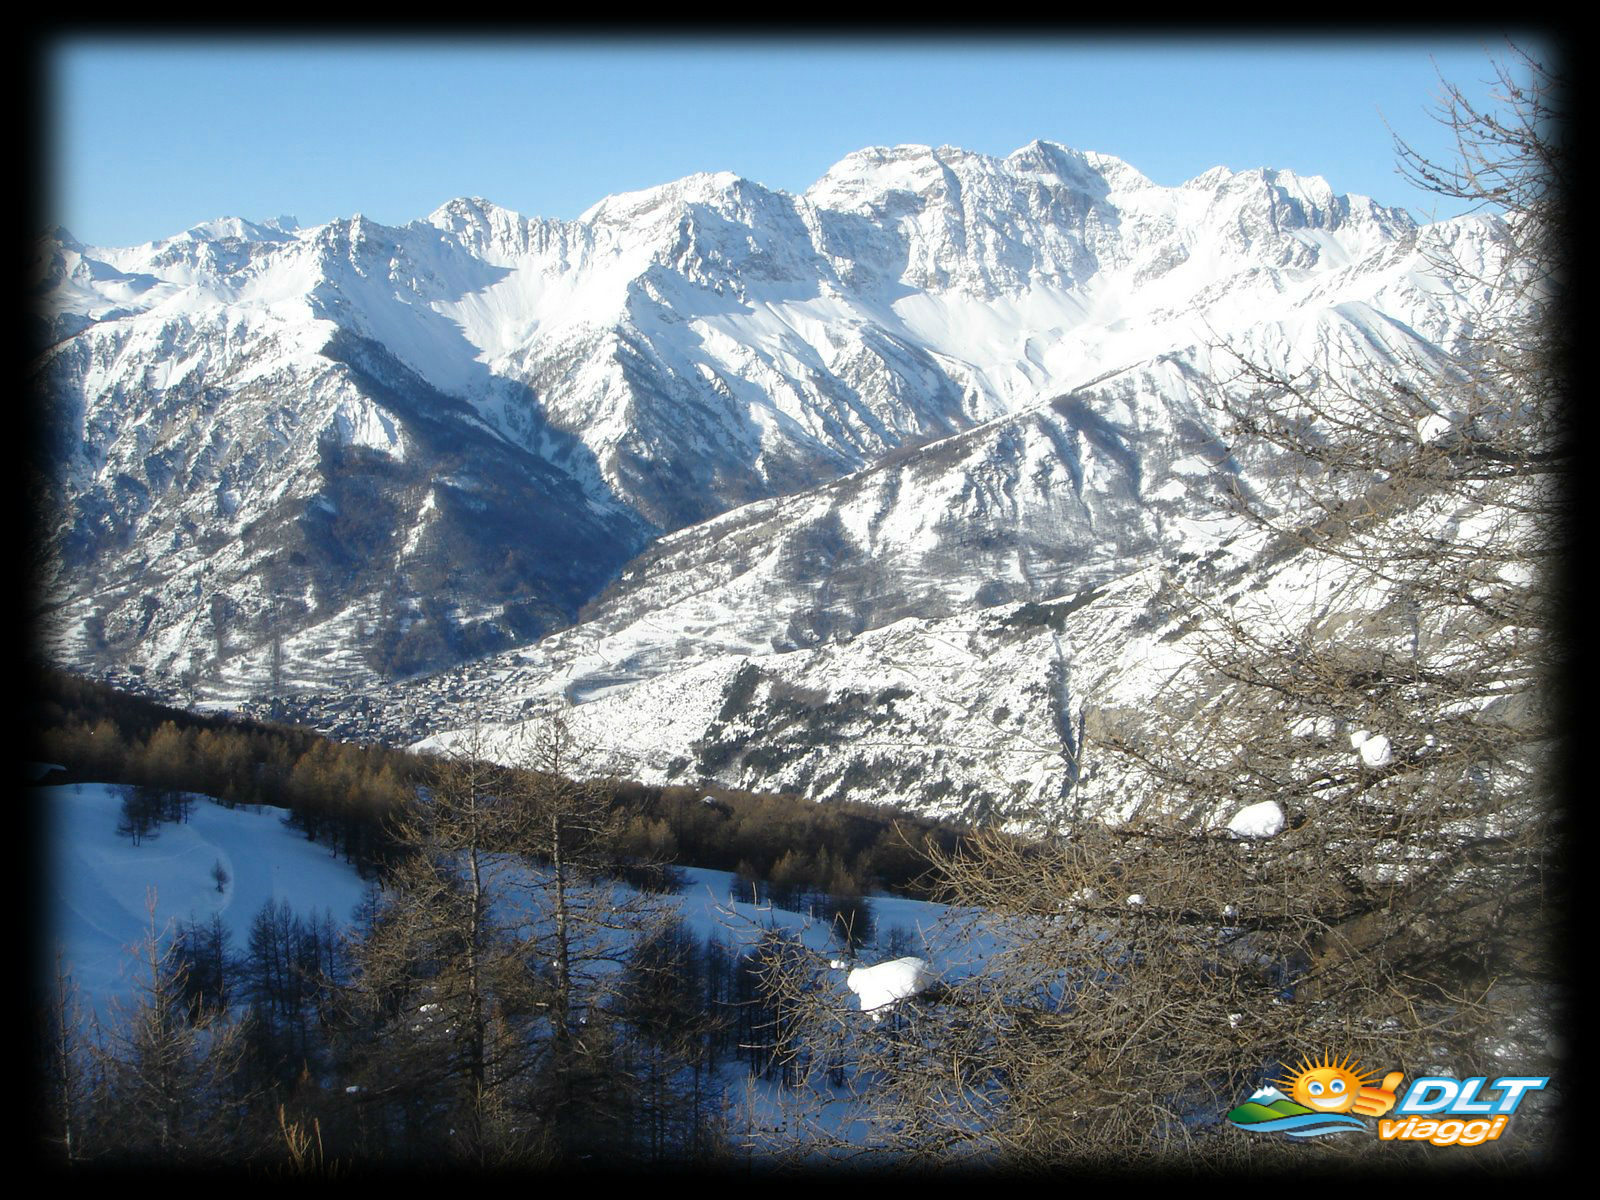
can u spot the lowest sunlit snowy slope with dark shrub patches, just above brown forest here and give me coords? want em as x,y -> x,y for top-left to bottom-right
400,457 -> 1531,837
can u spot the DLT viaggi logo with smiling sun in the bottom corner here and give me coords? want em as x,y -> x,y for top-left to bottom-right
1227,1054 -> 1550,1146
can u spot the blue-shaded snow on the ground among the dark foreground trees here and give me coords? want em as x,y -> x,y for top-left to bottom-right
40,784 -> 1036,1154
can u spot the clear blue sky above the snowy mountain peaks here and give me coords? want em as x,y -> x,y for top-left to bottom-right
42,30 -> 1542,245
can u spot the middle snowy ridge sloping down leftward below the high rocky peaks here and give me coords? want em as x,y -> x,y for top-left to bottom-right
353,280 -> 1465,725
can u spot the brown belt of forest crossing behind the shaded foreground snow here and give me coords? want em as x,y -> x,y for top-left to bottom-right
29,667 -> 966,907
